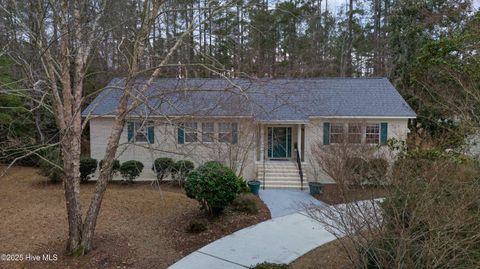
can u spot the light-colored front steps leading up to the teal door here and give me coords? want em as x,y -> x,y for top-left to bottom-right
257,161 -> 307,189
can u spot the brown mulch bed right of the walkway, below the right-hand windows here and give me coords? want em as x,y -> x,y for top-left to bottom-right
315,184 -> 388,205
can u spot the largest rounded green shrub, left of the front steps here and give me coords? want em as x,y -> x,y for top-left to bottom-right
185,162 -> 240,215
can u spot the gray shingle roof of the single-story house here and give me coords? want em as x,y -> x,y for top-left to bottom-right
82,78 -> 416,120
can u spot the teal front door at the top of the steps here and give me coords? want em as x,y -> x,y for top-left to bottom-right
268,127 -> 292,160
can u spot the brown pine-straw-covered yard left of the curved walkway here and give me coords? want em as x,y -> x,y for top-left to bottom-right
0,167 -> 270,268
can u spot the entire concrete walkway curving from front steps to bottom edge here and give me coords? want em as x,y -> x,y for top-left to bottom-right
169,189 -> 335,269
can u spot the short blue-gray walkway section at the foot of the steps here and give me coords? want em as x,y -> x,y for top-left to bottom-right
260,187 -> 327,218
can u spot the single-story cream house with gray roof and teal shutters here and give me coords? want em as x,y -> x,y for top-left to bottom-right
82,78 -> 416,188
